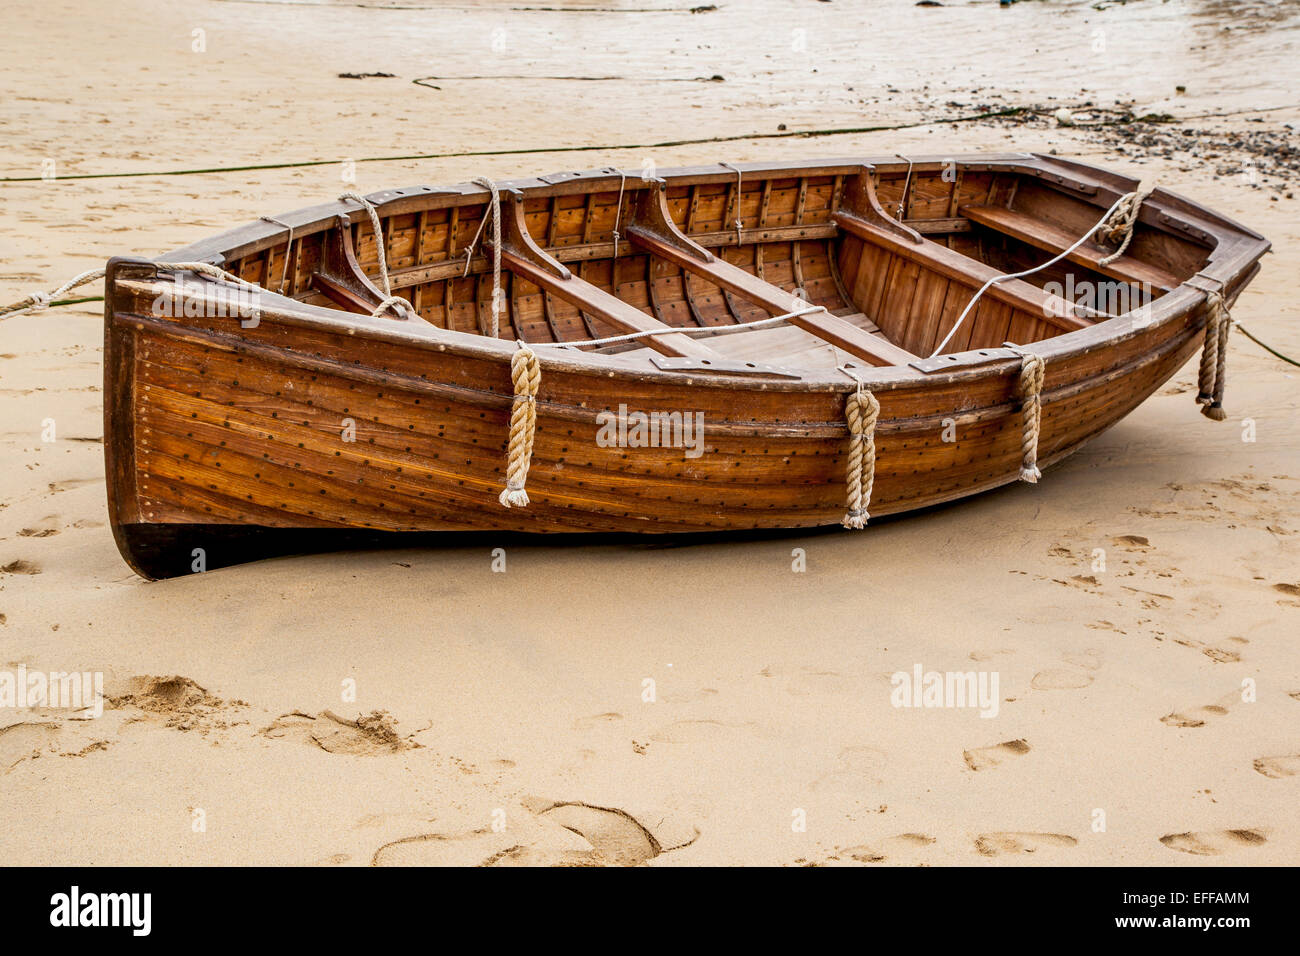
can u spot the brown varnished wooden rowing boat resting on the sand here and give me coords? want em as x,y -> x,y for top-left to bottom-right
104,153 -> 1269,578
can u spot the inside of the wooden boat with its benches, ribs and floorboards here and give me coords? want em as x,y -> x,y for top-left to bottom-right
218,168 -> 1204,371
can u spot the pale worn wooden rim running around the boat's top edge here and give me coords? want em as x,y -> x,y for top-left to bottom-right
142,152 -> 1270,392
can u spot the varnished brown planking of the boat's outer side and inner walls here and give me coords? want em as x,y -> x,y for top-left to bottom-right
105,157 -> 1266,574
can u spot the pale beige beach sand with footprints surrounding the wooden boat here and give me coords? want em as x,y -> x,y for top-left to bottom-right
0,0 -> 1300,865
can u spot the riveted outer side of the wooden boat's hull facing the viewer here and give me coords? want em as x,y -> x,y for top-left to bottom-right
105,153 -> 1268,578
